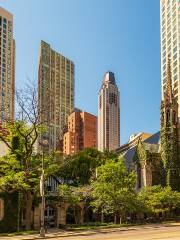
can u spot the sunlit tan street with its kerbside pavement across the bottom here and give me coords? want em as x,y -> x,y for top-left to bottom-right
0,223 -> 180,240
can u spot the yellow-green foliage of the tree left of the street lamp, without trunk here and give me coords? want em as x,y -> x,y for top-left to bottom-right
0,122 -> 40,192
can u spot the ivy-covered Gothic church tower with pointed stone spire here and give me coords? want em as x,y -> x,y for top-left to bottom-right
160,59 -> 180,191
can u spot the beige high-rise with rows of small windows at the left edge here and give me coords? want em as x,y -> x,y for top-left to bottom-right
0,7 -> 15,122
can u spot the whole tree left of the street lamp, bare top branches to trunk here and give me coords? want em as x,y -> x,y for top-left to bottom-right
0,86 -> 45,230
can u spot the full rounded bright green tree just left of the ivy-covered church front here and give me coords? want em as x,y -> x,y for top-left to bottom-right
92,158 -> 136,222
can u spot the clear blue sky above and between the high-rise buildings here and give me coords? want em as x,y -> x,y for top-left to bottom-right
0,0 -> 161,143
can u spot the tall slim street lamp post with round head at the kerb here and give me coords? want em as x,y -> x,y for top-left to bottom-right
40,140 -> 48,238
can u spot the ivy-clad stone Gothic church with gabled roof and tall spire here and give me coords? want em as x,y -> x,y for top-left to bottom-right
117,59 -> 180,191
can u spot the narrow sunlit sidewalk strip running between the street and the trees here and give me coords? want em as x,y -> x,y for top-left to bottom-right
0,223 -> 180,240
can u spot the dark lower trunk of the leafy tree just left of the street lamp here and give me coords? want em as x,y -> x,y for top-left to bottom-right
25,191 -> 32,230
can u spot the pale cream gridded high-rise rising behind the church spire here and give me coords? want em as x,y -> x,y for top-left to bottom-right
160,0 -> 180,119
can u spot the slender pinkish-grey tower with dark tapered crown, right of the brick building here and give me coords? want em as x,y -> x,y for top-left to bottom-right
98,72 -> 120,151
